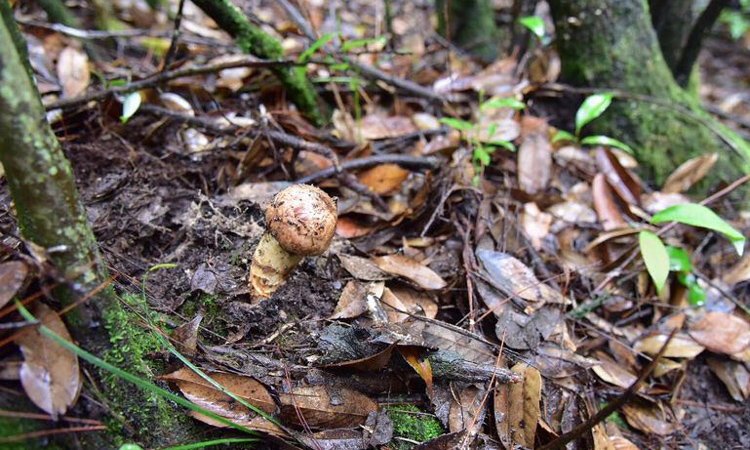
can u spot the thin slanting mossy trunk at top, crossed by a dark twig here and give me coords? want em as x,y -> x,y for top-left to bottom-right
193,0 -> 323,124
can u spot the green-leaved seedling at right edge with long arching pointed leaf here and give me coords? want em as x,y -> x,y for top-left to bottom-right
638,203 -> 745,305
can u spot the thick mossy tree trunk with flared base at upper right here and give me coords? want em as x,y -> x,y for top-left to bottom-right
549,0 -> 750,193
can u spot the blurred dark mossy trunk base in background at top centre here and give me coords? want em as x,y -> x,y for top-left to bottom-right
436,0 -> 510,63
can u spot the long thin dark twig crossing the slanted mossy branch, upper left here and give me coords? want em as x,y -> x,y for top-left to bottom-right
45,57 -> 306,111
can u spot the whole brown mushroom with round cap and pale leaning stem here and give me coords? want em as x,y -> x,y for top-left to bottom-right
250,184 -> 337,297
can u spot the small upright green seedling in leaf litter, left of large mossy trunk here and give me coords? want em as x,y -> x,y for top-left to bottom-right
440,93 -> 526,186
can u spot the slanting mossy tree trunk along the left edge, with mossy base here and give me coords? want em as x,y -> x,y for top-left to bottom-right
0,7 -> 197,448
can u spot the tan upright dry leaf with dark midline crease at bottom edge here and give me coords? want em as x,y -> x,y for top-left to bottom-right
505,363 -> 542,448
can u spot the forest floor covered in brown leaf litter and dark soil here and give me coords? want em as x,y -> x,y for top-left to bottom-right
0,2 -> 750,450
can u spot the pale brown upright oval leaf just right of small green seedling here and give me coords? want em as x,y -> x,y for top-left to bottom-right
518,116 -> 552,195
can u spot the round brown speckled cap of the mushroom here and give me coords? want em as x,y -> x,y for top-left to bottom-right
266,184 -> 337,256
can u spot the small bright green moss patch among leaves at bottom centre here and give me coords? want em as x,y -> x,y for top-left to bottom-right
386,404 -> 445,450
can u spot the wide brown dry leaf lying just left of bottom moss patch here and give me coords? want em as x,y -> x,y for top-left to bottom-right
279,385 -> 378,428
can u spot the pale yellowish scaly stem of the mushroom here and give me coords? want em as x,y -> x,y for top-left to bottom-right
250,233 -> 304,297
